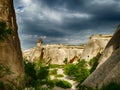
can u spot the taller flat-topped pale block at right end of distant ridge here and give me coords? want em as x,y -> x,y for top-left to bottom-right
81,34 -> 112,61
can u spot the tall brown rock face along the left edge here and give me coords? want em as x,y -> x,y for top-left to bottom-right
0,0 -> 24,85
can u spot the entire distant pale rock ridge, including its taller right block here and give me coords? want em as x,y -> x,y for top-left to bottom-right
23,34 -> 112,64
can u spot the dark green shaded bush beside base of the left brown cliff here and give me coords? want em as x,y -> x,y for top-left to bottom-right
24,60 -> 49,87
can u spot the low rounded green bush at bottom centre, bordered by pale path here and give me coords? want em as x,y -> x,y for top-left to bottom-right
55,80 -> 72,89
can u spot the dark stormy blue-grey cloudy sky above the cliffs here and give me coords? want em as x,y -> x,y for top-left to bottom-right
14,0 -> 120,50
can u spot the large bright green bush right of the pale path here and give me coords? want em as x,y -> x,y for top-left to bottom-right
64,60 -> 90,82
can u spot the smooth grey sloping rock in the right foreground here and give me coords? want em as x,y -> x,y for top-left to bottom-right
82,26 -> 120,88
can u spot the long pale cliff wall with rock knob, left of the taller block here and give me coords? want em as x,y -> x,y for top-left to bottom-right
23,39 -> 84,64
